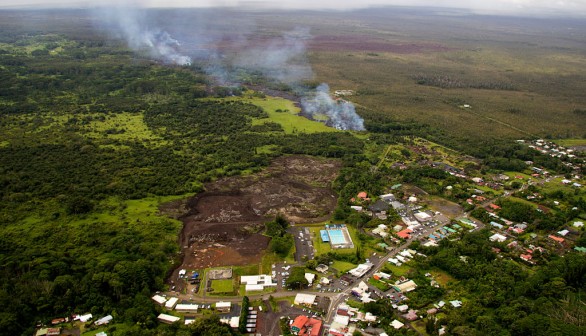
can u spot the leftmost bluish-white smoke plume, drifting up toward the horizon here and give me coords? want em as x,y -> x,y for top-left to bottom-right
95,5 -> 191,65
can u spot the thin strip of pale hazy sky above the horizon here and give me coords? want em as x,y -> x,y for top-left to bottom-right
0,0 -> 586,16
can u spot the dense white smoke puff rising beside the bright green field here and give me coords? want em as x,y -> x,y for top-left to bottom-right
301,83 -> 364,131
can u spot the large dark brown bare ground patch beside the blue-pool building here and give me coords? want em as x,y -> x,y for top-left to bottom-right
162,156 -> 340,269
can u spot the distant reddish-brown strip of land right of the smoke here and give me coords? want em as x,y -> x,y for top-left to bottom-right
309,35 -> 453,54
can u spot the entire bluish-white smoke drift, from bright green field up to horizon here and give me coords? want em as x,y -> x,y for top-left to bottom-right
90,4 -> 364,131
